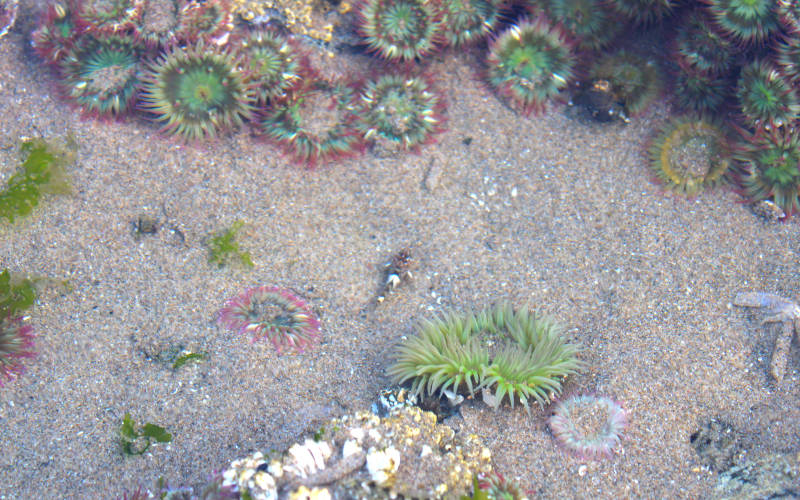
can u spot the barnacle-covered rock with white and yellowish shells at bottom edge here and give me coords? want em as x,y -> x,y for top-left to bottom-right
220,407 -> 492,500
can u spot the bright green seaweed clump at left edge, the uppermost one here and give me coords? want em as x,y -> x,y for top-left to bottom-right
0,139 -> 74,222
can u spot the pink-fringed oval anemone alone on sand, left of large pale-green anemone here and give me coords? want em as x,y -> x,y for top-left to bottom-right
218,286 -> 320,354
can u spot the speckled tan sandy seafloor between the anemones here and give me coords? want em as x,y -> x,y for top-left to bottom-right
0,7 -> 800,499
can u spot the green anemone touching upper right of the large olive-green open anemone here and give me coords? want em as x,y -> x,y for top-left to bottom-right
239,29 -> 307,104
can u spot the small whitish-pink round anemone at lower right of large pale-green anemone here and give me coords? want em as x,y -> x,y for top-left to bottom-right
548,395 -> 628,459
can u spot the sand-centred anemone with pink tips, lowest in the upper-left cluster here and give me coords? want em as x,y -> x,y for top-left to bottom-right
259,81 -> 363,167
